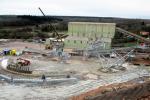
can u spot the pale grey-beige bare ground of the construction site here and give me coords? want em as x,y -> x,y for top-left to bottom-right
0,41 -> 150,100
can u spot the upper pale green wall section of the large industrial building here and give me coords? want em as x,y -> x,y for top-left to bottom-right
68,22 -> 116,38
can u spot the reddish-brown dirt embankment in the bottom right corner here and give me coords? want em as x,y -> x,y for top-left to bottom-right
70,79 -> 150,100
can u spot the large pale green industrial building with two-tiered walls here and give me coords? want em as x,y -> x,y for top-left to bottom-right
65,22 -> 116,50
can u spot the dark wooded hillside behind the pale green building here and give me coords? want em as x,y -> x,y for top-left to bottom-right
0,15 -> 150,38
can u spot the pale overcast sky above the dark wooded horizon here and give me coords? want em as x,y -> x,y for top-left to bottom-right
0,0 -> 150,19
